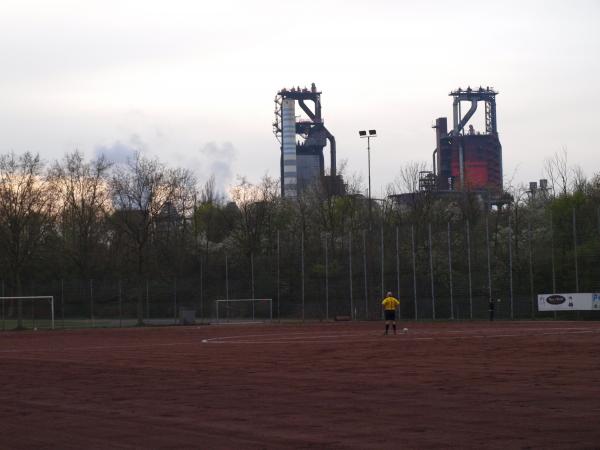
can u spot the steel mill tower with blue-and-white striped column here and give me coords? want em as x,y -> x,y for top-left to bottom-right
273,83 -> 344,198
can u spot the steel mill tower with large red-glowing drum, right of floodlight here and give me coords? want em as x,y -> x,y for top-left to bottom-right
432,87 -> 502,196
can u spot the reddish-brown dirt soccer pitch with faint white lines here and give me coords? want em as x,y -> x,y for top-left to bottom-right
0,322 -> 600,449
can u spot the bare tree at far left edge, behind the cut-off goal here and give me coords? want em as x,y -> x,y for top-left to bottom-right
0,153 -> 55,328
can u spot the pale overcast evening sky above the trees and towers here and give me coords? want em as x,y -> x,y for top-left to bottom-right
0,0 -> 600,195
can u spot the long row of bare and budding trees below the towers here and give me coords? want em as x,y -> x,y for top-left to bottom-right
0,151 -> 600,322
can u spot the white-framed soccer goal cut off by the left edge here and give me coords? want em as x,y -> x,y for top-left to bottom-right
0,295 -> 54,330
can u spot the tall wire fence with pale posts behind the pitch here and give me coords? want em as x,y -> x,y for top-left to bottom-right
1,208 -> 600,329
